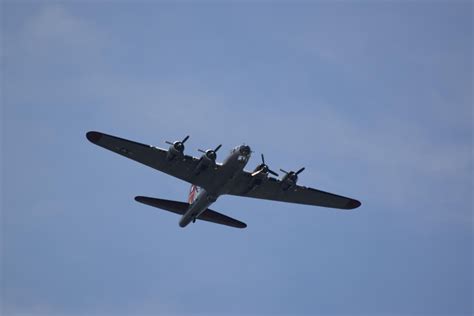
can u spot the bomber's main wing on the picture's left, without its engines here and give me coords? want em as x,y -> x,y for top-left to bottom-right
86,132 -> 215,187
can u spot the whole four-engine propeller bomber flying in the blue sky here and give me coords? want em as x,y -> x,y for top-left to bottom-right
86,131 -> 361,228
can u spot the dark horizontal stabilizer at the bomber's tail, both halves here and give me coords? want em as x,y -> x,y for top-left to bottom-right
135,196 -> 247,228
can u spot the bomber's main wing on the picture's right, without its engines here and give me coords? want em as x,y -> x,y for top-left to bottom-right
228,172 -> 361,210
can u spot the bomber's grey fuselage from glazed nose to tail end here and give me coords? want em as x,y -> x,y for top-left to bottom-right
179,145 -> 251,227
